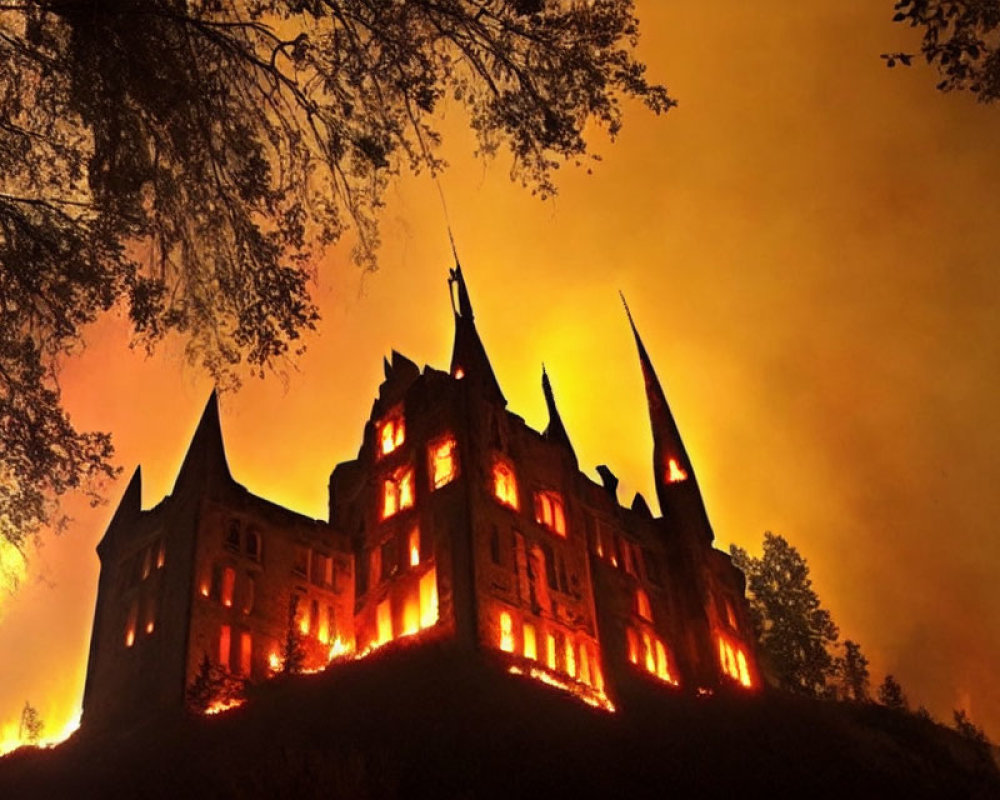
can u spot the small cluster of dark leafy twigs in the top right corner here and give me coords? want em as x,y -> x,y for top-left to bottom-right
882,0 -> 1000,103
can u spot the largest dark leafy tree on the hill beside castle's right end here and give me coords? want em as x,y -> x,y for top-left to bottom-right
730,531 -> 838,697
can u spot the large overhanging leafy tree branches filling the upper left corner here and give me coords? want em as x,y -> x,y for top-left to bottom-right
0,0 -> 674,547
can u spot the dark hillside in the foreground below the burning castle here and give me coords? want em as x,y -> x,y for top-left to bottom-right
0,642 -> 1000,800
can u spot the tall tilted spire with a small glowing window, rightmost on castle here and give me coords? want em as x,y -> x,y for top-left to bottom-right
618,292 -> 714,543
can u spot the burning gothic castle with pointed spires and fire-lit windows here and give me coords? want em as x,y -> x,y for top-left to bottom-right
83,268 -> 760,727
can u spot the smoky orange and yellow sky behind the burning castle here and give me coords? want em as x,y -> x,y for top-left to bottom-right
0,0 -> 1000,740
